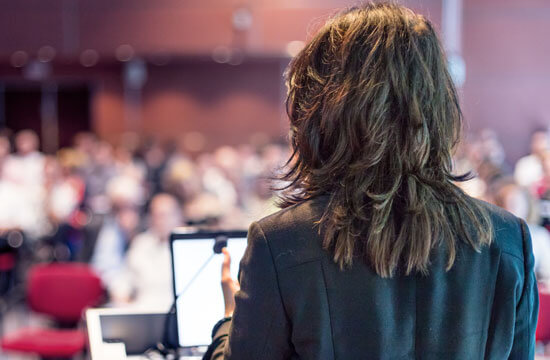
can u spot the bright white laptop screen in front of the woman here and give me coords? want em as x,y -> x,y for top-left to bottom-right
171,231 -> 247,347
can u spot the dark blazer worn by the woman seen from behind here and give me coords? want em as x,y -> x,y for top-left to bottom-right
207,197 -> 538,360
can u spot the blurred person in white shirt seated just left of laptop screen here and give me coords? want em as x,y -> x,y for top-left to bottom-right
109,193 -> 182,310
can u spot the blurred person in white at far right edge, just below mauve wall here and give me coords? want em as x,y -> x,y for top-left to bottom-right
514,129 -> 550,190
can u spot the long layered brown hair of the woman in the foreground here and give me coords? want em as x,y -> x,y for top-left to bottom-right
281,3 -> 493,277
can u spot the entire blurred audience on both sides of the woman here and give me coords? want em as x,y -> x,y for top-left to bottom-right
0,124 -> 550,307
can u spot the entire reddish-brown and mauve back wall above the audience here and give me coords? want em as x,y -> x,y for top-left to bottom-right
0,0 -> 550,160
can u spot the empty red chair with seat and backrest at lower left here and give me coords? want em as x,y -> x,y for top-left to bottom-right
0,263 -> 103,358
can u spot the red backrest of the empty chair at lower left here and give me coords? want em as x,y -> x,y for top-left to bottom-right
27,263 -> 103,324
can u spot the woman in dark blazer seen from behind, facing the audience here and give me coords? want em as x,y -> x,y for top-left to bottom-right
205,3 -> 538,360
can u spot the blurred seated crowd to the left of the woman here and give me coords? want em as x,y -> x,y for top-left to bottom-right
0,130 -> 288,307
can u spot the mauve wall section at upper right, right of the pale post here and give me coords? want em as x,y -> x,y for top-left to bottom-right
462,0 -> 550,160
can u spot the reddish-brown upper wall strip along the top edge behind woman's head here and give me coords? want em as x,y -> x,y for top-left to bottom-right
0,0 -> 441,58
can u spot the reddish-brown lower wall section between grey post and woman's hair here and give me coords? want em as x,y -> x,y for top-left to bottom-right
142,60 -> 286,145
